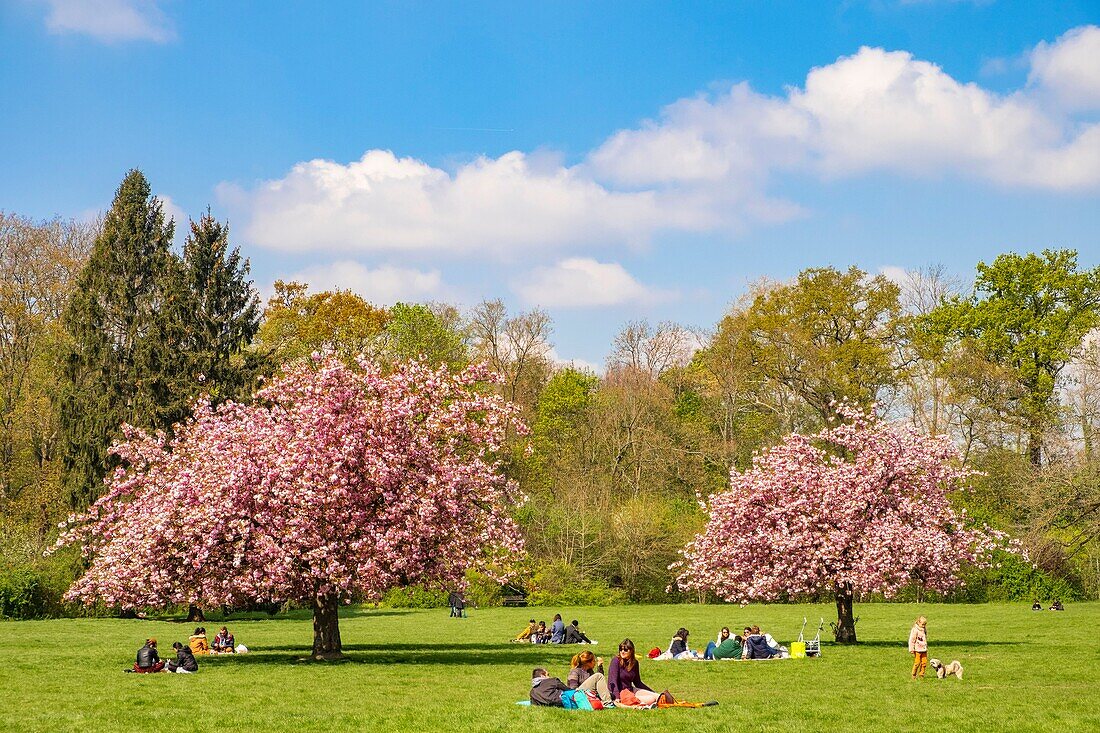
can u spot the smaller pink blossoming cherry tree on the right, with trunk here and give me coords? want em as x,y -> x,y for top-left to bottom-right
678,406 -> 1004,643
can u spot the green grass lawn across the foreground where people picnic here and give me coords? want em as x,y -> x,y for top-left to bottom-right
0,603 -> 1100,733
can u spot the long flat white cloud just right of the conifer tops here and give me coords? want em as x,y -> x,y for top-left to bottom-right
218,150 -> 730,255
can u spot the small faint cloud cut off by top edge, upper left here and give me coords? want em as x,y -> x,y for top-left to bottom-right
44,0 -> 175,43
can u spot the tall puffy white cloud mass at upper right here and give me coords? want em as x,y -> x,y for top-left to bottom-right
591,40 -> 1100,189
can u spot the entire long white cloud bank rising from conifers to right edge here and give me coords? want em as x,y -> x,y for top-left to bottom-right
219,26 -> 1100,258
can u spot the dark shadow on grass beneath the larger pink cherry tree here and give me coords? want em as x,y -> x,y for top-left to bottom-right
211,643 -> 589,667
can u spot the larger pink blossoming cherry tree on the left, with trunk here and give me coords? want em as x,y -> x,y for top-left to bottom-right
59,354 -> 526,658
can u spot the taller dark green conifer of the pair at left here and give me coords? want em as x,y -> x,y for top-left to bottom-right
61,171 -> 185,507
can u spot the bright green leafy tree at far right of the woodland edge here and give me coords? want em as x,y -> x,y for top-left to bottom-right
924,250 -> 1100,466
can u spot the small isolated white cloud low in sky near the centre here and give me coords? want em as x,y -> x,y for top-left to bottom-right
512,258 -> 673,308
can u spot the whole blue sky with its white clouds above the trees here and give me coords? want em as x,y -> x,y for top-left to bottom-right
0,0 -> 1100,364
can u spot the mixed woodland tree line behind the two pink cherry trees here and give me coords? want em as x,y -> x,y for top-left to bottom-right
0,171 -> 1100,615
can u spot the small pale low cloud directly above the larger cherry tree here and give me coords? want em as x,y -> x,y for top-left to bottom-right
283,260 -> 446,306
